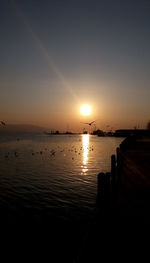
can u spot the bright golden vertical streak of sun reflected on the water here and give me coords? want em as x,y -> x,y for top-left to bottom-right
81,134 -> 89,174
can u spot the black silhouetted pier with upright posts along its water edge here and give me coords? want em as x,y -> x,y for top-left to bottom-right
81,135 -> 150,262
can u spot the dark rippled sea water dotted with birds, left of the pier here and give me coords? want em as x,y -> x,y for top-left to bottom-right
0,135 -> 122,226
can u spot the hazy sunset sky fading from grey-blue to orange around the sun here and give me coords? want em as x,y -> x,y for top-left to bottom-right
0,0 -> 150,131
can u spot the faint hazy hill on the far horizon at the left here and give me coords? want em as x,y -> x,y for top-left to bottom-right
0,124 -> 46,133
